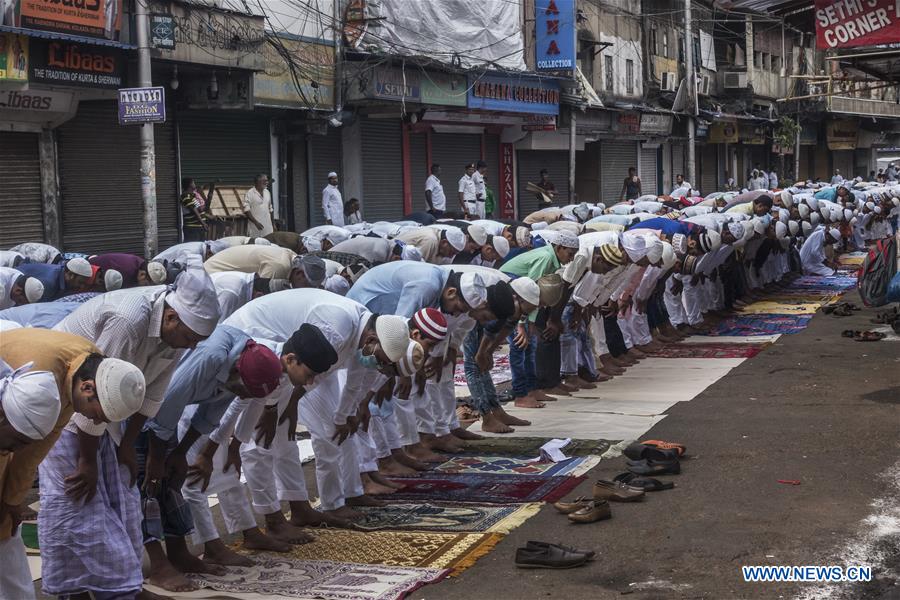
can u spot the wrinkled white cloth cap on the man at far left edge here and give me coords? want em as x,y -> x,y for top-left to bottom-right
0,361 -> 61,440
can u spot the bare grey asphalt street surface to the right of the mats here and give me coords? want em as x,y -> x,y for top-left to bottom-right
422,302 -> 900,600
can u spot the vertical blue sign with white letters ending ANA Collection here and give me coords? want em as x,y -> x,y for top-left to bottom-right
534,0 -> 575,71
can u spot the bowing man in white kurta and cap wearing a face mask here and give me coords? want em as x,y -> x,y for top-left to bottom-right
225,290 -> 409,519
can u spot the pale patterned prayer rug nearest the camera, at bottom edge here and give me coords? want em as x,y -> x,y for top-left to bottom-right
172,546 -> 447,600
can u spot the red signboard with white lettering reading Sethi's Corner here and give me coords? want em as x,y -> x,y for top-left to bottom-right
816,0 -> 900,50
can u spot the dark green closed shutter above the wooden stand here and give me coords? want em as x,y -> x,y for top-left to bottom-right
178,110 -> 273,187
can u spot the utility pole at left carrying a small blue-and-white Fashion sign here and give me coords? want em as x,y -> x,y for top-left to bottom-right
134,0 -> 159,259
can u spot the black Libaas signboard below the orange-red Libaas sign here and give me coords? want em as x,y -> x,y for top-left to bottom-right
29,38 -> 125,90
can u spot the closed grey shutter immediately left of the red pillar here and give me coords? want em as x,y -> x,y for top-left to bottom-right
360,119 -> 402,222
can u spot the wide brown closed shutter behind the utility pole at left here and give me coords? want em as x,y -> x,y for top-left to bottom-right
57,101 -> 179,255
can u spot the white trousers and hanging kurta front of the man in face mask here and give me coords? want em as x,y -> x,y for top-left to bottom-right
299,372 -> 363,510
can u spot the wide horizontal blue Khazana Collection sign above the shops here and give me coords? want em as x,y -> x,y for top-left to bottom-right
468,74 -> 560,115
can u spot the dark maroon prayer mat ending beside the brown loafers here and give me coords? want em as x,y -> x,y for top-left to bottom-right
385,473 -> 584,504
